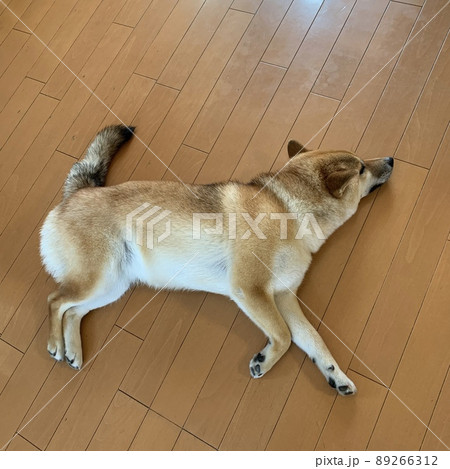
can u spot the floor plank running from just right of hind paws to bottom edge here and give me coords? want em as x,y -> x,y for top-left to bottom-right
47,328 -> 141,451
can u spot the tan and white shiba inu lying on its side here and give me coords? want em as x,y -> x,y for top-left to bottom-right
41,125 -> 394,395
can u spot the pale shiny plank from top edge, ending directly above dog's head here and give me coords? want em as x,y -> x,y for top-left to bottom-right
313,0 -> 389,100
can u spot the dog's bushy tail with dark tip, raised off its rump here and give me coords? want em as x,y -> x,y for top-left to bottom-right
63,125 -> 135,199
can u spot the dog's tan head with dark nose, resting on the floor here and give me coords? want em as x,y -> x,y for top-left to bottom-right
288,140 -> 394,201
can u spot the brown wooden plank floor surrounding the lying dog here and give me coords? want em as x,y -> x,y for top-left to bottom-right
0,0 -> 450,450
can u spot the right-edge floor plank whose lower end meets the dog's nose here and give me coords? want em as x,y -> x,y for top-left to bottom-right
396,37 -> 450,168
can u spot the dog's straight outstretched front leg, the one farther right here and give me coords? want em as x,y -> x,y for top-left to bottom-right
275,290 -> 356,396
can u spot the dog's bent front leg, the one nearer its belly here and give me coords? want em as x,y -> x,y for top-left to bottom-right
233,288 -> 291,378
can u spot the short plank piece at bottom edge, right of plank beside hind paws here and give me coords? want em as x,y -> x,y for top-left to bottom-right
87,391 -> 147,451
